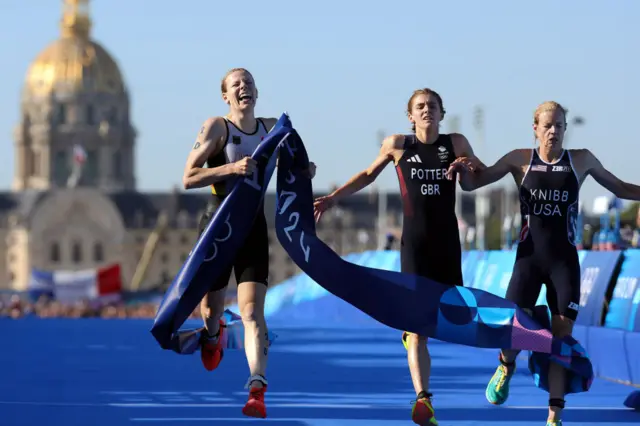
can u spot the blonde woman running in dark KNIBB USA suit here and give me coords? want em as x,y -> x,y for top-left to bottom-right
452,102 -> 640,426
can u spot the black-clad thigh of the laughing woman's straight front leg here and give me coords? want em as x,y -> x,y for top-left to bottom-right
233,213 -> 269,286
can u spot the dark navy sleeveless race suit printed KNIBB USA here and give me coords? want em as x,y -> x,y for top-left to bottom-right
506,149 -> 580,320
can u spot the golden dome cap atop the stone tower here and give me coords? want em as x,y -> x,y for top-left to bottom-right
25,0 -> 124,95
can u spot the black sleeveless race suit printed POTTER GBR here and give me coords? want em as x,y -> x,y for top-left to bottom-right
396,135 -> 462,285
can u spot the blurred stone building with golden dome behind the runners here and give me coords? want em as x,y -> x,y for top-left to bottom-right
0,0 -> 492,291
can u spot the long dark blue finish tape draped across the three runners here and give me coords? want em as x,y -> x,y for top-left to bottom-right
152,115 -> 593,393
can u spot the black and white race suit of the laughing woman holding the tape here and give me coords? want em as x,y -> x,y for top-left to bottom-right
198,118 -> 269,291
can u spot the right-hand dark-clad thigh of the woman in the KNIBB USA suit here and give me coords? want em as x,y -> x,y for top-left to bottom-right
547,255 -> 580,321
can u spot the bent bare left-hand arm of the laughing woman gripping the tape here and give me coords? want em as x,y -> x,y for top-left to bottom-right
182,117 -> 255,189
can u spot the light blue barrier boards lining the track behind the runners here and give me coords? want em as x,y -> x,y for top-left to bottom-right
266,250 -> 640,409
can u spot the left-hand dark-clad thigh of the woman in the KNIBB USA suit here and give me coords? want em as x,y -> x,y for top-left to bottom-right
505,256 -> 543,309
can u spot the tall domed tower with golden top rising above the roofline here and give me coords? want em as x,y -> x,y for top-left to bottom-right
12,0 -> 135,190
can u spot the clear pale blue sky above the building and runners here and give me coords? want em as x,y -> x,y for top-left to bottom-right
0,0 -> 640,213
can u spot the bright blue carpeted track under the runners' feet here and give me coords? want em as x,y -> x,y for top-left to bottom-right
0,319 -> 640,426
